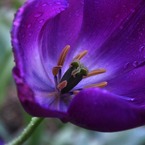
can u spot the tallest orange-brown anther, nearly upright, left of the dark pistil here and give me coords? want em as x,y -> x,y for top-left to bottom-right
57,45 -> 70,66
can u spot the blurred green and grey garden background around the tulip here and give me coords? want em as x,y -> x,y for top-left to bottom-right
0,0 -> 145,145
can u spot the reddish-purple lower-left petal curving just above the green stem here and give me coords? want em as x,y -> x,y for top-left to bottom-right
13,68 -> 66,118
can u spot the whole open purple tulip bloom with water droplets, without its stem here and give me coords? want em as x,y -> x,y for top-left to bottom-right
12,0 -> 145,132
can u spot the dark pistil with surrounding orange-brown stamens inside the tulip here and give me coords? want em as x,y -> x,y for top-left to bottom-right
52,45 -> 107,94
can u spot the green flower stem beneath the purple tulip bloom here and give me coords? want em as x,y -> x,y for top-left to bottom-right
6,117 -> 44,145
